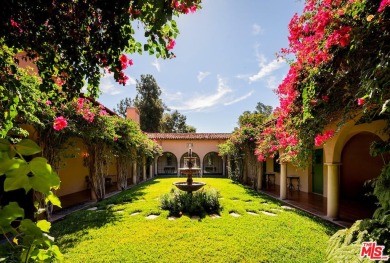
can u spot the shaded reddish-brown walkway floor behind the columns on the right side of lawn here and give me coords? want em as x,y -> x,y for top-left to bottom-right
260,185 -> 376,228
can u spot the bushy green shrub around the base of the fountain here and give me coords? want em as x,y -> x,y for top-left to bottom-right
160,188 -> 221,215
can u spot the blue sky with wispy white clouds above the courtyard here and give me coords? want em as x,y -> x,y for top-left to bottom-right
98,0 -> 303,132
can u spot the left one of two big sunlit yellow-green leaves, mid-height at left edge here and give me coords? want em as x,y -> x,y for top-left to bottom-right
4,162 -> 31,193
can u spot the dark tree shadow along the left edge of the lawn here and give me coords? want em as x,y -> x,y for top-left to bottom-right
50,179 -> 158,249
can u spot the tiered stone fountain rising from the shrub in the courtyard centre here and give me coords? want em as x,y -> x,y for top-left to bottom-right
173,144 -> 206,193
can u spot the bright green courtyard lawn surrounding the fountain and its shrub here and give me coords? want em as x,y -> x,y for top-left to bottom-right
52,178 -> 337,263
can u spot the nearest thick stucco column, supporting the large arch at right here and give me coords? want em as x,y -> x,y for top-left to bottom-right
325,163 -> 341,218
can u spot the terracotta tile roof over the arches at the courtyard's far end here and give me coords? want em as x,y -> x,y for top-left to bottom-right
147,133 -> 230,140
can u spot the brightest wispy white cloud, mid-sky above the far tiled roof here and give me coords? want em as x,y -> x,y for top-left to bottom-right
169,76 -> 232,111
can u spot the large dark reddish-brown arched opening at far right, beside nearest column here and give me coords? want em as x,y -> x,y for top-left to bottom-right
340,132 -> 384,220
